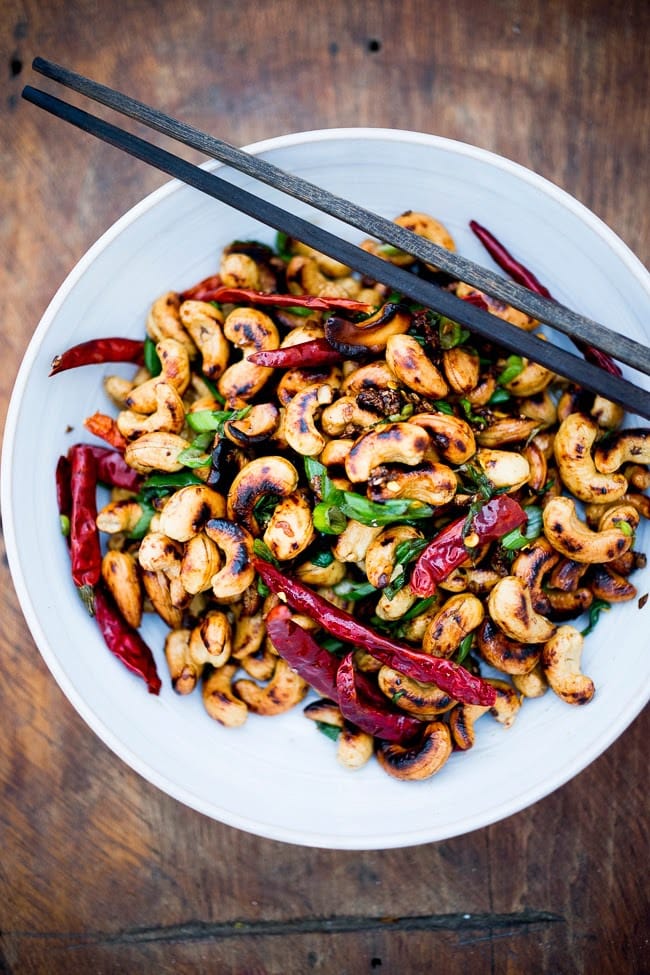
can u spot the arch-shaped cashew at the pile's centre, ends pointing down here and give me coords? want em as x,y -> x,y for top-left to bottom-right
345,423 -> 429,483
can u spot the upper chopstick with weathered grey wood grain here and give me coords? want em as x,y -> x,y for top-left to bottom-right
33,57 -> 650,375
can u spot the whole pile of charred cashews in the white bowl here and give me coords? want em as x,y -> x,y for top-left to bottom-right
92,211 -> 650,779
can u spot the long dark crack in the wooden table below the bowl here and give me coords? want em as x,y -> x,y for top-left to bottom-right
0,910 -> 565,948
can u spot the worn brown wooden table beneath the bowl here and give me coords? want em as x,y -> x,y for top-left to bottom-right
0,0 -> 650,975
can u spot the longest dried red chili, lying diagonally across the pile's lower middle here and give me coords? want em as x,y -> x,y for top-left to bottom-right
253,558 -> 496,707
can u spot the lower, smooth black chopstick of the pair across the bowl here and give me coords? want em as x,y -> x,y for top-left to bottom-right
22,86 -> 650,419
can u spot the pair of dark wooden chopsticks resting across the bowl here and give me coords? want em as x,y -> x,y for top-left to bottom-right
22,58 -> 650,419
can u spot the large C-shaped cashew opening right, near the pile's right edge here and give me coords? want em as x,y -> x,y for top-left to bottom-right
553,413 -> 627,504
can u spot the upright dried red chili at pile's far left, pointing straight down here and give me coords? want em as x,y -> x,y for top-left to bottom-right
68,444 -> 102,612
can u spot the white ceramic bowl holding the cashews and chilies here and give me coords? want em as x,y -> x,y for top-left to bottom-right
2,129 -> 650,849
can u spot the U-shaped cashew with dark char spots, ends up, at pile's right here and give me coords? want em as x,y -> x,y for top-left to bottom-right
544,497 -> 634,562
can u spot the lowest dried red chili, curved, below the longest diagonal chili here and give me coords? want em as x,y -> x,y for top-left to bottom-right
336,653 -> 422,741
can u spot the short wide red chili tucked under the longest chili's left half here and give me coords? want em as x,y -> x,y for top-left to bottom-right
264,604 -> 339,700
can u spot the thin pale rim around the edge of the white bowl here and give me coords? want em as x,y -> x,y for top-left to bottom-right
5,126 -> 650,851
